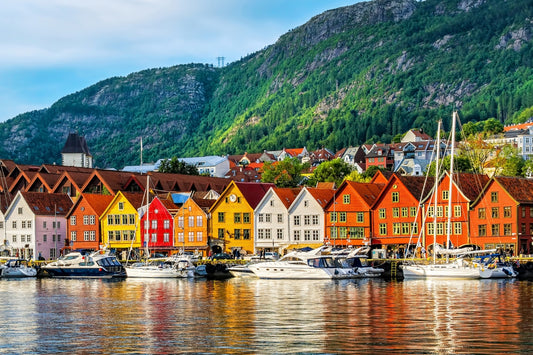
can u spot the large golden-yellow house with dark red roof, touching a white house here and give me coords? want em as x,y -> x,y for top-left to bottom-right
209,181 -> 274,255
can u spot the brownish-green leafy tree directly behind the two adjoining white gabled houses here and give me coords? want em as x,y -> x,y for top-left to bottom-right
261,158 -> 309,187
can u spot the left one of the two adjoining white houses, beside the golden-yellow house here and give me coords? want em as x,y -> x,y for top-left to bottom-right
254,187 -> 301,254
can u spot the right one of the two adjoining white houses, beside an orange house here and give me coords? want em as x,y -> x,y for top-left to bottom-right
289,187 -> 335,247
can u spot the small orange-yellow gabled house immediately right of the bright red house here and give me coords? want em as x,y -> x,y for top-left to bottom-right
174,194 -> 216,256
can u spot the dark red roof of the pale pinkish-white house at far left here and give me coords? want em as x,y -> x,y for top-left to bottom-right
20,192 -> 72,216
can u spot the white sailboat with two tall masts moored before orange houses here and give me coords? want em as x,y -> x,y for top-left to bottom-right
401,112 -> 481,279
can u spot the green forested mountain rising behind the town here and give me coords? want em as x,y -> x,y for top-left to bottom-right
0,0 -> 533,168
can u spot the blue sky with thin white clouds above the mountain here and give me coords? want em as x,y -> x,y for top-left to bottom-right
0,0 -> 361,121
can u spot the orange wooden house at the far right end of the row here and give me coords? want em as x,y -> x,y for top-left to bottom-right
470,176 -> 533,255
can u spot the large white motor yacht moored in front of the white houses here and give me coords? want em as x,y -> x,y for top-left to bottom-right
248,247 -> 357,279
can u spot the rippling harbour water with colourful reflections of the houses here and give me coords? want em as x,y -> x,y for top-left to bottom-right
0,279 -> 533,354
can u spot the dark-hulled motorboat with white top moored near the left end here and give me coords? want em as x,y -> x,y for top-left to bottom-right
41,250 -> 126,278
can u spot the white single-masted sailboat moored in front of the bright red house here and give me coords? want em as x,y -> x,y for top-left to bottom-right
125,175 -> 193,278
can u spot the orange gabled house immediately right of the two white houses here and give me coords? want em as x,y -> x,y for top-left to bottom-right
324,180 -> 385,247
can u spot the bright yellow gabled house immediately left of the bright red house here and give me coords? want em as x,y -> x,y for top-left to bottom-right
100,191 -> 143,259
